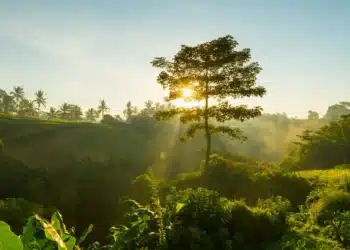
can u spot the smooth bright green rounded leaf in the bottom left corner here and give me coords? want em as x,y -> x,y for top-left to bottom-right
0,221 -> 23,250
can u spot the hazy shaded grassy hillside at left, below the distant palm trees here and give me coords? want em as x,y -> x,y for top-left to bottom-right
0,116 -> 147,170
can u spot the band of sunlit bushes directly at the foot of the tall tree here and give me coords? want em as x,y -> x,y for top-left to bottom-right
169,155 -> 312,208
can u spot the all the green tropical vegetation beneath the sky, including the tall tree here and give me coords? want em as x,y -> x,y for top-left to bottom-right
0,36 -> 350,250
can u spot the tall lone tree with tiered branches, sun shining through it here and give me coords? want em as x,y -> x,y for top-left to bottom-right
152,35 -> 266,165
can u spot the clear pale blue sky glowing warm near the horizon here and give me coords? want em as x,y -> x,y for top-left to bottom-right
0,0 -> 350,116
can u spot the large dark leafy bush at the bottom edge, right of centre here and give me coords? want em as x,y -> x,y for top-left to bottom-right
167,188 -> 287,249
